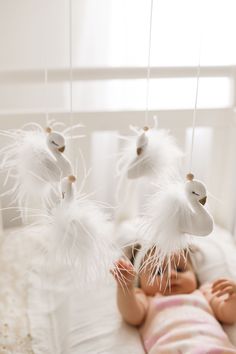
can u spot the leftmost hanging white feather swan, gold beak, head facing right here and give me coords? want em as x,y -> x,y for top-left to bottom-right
0,123 -> 72,219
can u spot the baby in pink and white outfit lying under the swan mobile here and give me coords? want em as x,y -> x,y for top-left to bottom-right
112,255 -> 236,354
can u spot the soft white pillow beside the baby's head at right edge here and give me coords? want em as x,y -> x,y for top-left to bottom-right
192,226 -> 236,346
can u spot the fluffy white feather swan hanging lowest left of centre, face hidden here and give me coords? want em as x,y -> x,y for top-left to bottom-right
41,176 -> 117,286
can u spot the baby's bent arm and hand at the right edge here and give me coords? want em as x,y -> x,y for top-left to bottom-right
202,278 -> 236,324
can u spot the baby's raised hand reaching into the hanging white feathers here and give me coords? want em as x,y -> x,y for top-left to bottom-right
111,259 -> 136,288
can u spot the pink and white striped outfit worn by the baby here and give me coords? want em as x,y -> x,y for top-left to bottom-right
140,290 -> 236,354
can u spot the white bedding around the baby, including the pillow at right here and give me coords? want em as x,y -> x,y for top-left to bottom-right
0,227 -> 236,354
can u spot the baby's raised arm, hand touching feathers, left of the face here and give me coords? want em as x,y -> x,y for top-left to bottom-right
112,259 -> 148,326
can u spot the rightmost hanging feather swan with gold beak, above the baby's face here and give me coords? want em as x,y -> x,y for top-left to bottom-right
139,174 -> 214,280
